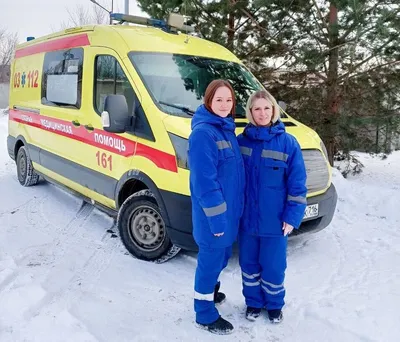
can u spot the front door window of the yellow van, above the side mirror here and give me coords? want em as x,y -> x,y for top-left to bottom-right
94,55 -> 135,114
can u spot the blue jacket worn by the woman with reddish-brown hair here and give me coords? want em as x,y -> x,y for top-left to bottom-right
189,105 -> 245,248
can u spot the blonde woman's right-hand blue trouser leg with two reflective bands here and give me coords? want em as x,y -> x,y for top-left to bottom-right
260,237 -> 287,310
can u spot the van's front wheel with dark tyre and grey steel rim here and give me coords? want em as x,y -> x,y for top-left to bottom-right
117,190 -> 180,263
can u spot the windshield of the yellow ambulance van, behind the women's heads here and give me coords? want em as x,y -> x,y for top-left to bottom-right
129,52 -> 262,118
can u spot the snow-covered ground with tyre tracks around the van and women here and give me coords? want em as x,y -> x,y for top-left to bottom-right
0,112 -> 400,342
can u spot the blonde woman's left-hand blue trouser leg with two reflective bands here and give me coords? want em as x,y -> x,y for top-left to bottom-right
239,234 -> 265,308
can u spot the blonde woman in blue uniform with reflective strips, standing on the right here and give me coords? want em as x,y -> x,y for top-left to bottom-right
238,90 -> 307,323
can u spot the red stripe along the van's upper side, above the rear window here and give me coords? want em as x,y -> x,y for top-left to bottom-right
15,33 -> 90,58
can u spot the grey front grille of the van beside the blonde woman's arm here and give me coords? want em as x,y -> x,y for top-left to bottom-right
302,150 -> 329,193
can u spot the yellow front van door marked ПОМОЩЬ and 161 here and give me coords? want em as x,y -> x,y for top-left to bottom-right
81,47 -> 140,208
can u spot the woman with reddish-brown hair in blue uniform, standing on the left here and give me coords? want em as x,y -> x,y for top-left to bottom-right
189,80 -> 245,334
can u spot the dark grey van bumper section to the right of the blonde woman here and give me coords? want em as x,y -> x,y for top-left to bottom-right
290,184 -> 337,236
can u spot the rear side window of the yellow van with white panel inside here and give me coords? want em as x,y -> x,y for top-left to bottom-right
42,48 -> 83,109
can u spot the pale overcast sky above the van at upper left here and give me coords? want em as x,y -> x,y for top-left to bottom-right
0,0 -> 147,42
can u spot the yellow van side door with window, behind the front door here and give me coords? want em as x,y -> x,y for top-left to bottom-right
36,47 -> 98,196
